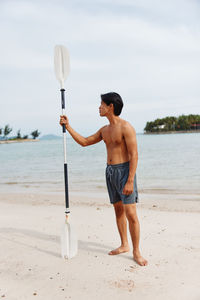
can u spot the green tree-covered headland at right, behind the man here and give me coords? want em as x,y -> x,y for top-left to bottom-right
144,115 -> 200,132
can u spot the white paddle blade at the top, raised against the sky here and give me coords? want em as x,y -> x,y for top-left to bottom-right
54,45 -> 70,88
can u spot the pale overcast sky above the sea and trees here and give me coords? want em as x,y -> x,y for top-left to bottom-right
0,0 -> 200,135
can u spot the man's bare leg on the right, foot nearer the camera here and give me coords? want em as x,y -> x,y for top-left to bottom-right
124,203 -> 148,266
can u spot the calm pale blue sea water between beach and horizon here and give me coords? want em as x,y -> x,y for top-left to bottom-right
0,133 -> 200,200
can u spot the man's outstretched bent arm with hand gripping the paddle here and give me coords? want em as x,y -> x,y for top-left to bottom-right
60,116 -> 102,147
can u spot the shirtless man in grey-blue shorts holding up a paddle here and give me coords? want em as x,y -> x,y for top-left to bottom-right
60,93 -> 147,266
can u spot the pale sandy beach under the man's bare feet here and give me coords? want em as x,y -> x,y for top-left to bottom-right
0,193 -> 200,300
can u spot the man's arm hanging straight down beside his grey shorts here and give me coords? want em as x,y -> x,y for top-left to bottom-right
123,123 -> 138,195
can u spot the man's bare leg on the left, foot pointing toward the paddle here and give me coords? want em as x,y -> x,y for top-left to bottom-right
108,201 -> 130,255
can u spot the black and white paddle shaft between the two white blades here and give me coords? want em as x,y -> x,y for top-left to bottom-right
60,89 -> 70,214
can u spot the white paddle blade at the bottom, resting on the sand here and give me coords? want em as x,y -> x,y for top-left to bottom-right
61,222 -> 78,259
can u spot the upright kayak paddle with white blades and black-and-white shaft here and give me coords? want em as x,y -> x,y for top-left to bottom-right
54,45 -> 78,259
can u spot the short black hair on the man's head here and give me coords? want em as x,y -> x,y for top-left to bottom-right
101,92 -> 124,116
